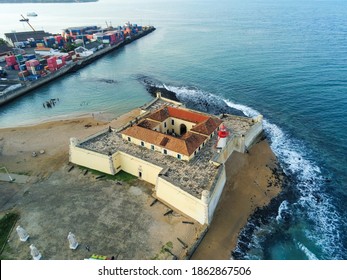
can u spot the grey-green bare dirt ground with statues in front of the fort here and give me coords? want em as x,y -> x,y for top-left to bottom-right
1,166 -> 200,260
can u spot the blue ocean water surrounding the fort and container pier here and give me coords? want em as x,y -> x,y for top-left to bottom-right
0,0 -> 347,259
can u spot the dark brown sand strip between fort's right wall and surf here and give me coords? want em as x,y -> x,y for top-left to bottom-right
192,140 -> 282,260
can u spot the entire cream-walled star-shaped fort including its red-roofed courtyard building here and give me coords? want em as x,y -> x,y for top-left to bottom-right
69,95 -> 262,224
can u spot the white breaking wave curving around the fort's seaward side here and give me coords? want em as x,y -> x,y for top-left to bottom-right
162,85 -> 344,259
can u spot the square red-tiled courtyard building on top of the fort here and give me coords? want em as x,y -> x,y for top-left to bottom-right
122,106 -> 222,161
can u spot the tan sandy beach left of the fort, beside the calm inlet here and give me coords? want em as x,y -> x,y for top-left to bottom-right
0,109 -> 140,181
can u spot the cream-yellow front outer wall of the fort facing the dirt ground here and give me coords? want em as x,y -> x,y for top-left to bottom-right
70,135 -> 225,224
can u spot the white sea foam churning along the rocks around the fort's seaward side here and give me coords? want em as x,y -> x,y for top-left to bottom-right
164,85 -> 343,259
